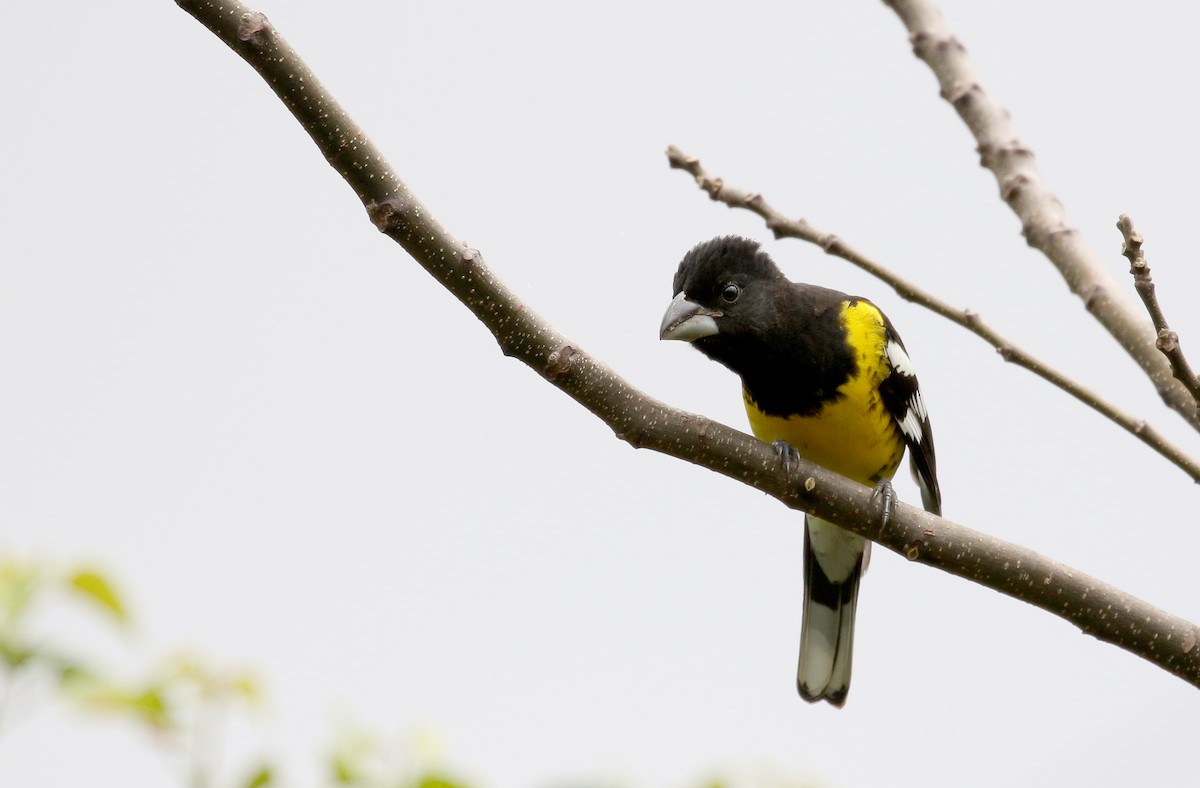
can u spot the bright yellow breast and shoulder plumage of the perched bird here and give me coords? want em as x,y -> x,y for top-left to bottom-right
742,301 -> 905,486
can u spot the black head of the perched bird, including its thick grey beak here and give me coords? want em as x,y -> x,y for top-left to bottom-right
659,235 -> 787,372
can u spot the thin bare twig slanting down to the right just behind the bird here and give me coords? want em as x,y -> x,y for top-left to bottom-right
667,145 -> 1200,483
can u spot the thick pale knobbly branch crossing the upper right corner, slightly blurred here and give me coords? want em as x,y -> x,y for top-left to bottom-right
883,0 -> 1200,429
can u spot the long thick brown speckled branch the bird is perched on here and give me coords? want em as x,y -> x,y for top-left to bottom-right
176,0 -> 1200,687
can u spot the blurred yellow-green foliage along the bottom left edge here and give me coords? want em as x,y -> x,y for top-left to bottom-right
0,557 -> 811,788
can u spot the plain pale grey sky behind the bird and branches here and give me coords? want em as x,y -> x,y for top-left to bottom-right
0,0 -> 1200,788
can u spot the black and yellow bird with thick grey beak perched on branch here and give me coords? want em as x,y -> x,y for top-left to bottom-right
659,235 -> 942,708
